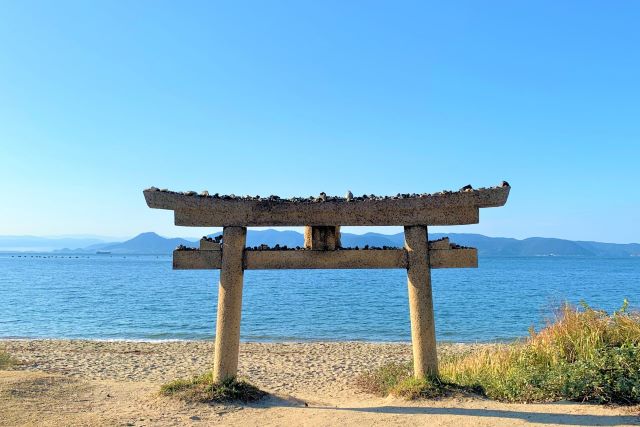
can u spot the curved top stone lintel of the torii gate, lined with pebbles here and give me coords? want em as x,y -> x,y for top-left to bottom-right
144,185 -> 510,227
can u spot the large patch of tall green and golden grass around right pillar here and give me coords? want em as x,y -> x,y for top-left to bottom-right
358,301 -> 640,404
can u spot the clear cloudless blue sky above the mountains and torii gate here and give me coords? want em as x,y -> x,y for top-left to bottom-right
0,0 -> 640,242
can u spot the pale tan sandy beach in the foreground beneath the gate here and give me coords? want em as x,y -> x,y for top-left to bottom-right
0,340 -> 640,426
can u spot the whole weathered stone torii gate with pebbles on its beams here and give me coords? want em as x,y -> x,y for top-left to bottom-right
144,182 -> 510,382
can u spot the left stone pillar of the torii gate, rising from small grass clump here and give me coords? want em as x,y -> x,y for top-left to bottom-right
213,227 -> 247,383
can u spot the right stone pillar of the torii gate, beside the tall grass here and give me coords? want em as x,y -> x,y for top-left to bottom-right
404,225 -> 438,378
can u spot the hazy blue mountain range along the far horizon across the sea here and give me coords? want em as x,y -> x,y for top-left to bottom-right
0,229 -> 640,257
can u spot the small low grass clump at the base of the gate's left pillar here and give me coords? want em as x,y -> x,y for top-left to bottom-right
160,372 -> 266,403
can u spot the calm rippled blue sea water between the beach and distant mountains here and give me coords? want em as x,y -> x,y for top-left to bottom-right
0,254 -> 640,342
